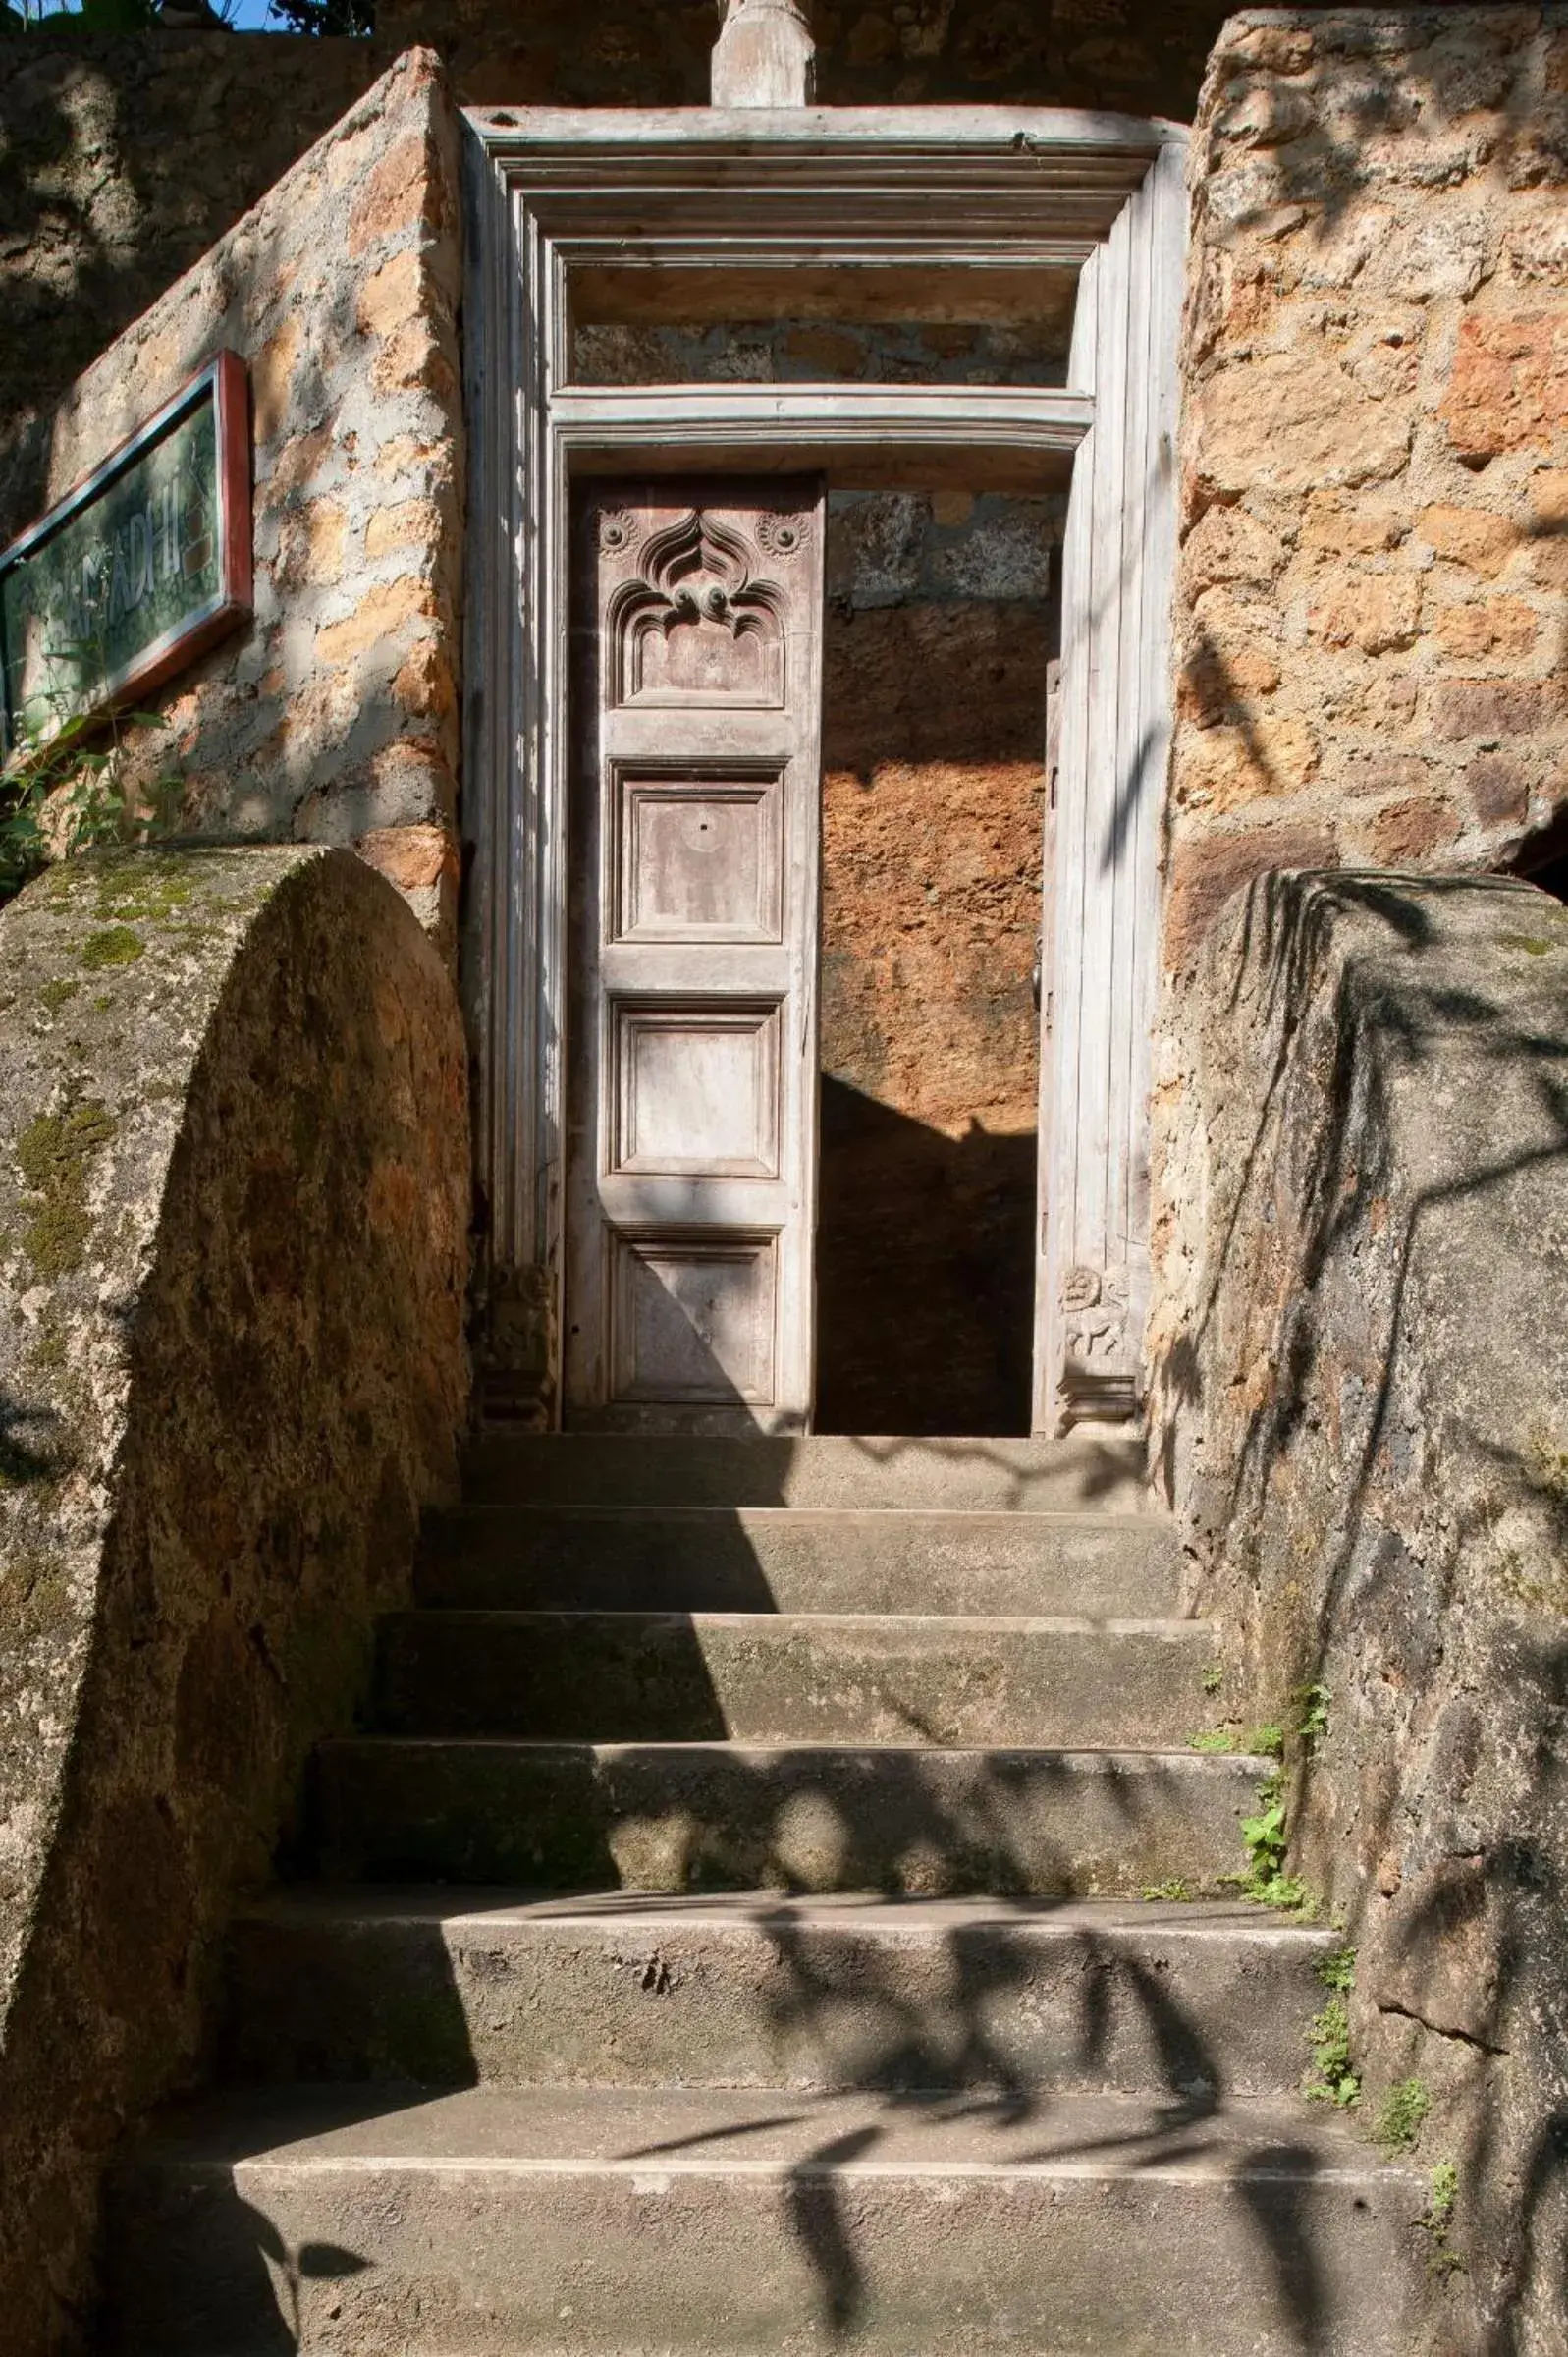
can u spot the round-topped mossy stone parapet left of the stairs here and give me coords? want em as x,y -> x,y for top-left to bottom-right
0,847 -> 466,2357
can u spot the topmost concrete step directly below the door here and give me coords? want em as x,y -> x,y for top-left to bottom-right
464,1426 -> 1149,1513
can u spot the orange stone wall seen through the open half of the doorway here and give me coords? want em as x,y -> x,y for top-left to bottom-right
818,490 -> 1063,1433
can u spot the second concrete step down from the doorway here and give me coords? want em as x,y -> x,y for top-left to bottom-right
419,1507 -> 1179,1617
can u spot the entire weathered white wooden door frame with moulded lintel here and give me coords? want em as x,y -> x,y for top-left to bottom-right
462,108 -> 1186,1431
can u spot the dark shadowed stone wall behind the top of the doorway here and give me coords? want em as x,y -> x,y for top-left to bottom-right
0,0 -> 1226,464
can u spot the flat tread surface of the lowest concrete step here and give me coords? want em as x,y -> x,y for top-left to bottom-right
128,2086 -> 1417,2185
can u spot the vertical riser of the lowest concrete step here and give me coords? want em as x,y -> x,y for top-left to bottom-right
113,2152 -> 1433,2357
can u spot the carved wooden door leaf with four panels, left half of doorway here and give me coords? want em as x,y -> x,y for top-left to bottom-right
564,476 -> 826,1433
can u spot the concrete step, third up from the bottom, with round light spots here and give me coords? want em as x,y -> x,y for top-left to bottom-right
316,1737 -> 1273,1897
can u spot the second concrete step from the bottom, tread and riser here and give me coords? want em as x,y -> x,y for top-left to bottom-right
231,1888 -> 1337,2098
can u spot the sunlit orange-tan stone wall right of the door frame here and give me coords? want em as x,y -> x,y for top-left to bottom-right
1153,7 -> 1568,1355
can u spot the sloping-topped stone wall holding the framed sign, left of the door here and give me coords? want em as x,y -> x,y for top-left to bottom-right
10,52 -> 462,945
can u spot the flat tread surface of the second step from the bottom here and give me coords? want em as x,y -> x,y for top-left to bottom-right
241,1884 -> 1339,1949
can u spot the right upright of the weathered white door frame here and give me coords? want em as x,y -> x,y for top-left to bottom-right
1035,148 -> 1186,1433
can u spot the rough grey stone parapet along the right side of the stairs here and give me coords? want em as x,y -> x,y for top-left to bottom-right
1158,872 -> 1568,2357
